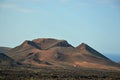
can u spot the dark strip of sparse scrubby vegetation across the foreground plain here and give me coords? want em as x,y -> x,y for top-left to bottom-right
0,68 -> 120,80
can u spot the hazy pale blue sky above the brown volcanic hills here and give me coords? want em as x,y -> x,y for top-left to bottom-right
0,0 -> 120,54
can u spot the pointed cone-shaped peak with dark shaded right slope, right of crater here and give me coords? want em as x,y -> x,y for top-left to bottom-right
76,43 -> 112,63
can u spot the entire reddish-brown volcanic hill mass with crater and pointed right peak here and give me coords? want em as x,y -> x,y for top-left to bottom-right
7,38 -> 118,69
